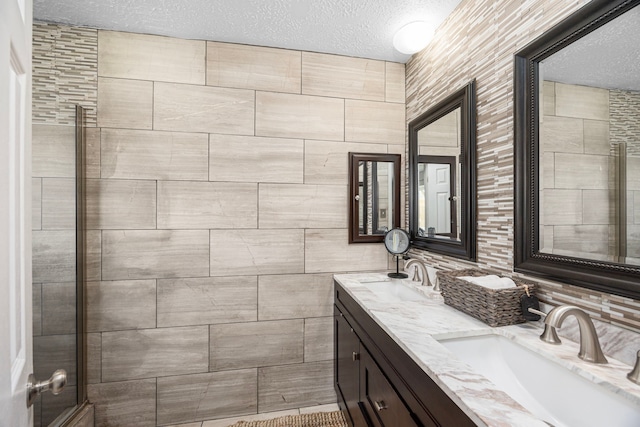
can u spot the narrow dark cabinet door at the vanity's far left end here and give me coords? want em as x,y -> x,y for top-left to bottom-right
334,309 -> 367,427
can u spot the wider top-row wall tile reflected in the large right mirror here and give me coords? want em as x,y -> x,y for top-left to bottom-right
556,83 -> 609,121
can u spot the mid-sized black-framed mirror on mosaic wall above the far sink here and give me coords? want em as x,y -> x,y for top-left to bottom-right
409,81 -> 476,261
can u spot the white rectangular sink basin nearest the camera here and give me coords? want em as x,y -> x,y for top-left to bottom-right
439,335 -> 640,427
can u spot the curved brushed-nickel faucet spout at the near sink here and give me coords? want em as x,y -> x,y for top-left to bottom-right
540,305 -> 607,363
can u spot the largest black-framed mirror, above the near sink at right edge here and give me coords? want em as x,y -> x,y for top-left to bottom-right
514,0 -> 640,299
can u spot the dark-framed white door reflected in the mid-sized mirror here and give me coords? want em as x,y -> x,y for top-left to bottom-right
418,156 -> 458,238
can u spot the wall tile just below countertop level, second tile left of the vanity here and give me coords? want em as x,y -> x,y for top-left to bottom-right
158,276 -> 258,327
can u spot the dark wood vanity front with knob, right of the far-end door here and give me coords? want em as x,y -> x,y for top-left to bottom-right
360,345 -> 418,427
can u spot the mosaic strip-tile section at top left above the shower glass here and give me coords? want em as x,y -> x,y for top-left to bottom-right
33,22 -> 98,127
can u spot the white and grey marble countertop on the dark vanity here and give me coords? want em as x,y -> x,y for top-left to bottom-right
334,273 -> 640,427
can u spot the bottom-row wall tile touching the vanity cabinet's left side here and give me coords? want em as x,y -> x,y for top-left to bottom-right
258,361 -> 336,412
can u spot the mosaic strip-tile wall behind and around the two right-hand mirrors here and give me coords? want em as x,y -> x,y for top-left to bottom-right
407,0 -> 640,332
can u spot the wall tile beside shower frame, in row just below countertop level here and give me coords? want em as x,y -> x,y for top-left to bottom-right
86,280 -> 156,332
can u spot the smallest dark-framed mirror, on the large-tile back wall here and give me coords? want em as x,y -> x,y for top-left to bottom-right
349,153 -> 401,243
